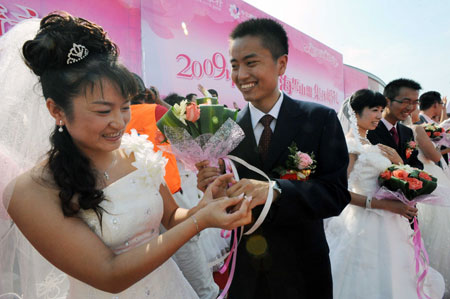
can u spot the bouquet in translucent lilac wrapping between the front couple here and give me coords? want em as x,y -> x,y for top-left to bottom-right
156,98 -> 244,170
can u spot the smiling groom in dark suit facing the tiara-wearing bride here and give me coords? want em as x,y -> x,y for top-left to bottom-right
198,19 -> 350,299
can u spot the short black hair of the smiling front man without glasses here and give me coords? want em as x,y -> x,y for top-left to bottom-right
230,18 -> 289,60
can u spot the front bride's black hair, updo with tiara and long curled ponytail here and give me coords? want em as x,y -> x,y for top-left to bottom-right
22,12 -> 137,219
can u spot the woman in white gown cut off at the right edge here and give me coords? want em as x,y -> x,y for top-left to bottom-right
410,109 -> 450,299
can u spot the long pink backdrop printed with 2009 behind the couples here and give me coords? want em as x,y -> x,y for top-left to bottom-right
0,0 -> 367,109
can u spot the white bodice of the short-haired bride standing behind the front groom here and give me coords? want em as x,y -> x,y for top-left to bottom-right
347,138 -> 392,195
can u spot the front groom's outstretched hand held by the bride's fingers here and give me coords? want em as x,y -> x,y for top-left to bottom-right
227,179 -> 278,209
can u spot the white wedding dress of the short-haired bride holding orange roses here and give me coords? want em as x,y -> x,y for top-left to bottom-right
326,138 -> 444,299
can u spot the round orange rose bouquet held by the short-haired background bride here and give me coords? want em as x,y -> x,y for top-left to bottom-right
378,164 -> 437,201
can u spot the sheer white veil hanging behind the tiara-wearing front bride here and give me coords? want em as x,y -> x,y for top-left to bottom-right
0,19 -> 68,299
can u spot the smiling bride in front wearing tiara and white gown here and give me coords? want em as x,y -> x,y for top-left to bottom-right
0,14 -> 251,299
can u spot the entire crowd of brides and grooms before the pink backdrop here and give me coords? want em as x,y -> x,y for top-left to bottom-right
0,12 -> 450,299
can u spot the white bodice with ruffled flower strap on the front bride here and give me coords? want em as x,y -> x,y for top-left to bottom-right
78,130 -> 167,254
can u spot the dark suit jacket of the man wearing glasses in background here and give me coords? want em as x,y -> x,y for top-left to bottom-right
367,121 -> 423,169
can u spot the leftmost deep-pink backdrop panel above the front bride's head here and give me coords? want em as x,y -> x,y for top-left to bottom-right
0,0 -> 142,74
